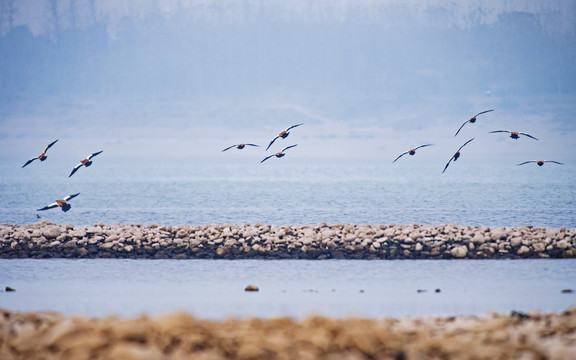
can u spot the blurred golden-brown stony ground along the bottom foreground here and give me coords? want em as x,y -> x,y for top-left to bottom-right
0,306 -> 576,360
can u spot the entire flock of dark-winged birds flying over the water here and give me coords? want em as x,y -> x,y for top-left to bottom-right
22,109 -> 564,212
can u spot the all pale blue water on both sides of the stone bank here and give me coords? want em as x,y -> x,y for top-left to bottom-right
0,156 -> 576,318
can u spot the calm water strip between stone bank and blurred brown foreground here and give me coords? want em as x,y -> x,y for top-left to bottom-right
0,259 -> 576,319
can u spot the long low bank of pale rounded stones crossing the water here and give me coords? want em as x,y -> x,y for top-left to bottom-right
0,221 -> 576,259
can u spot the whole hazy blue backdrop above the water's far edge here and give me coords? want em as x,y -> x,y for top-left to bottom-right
0,0 -> 576,163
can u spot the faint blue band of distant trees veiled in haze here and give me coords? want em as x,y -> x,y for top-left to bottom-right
0,1 -> 576,103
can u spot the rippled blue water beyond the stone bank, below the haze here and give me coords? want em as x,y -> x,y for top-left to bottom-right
0,159 -> 576,227
